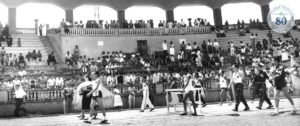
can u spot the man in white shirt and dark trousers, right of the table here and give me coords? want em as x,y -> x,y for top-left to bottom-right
230,65 -> 250,112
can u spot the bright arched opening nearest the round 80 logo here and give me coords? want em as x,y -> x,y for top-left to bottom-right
221,3 -> 262,24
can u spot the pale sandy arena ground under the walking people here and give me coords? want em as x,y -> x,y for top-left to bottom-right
0,98 -> 300,126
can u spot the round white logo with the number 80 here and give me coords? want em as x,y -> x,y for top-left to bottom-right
268,5 -> 295,33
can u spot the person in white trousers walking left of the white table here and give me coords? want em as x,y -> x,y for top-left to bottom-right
140,77 -> 154,112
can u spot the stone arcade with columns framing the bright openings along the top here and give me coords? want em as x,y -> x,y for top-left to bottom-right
0,0 -> 278,28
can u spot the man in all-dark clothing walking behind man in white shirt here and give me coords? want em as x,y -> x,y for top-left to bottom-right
253,65 -> 273,109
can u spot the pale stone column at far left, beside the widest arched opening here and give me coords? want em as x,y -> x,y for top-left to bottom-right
8,8 -> 17,32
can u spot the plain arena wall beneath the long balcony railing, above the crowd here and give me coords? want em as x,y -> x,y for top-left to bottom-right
47,34 -> 216,58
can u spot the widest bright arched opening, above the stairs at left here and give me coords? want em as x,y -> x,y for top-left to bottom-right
17,3 -> 65,28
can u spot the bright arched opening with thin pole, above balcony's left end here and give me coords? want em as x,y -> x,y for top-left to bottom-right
73,5 -> 117,24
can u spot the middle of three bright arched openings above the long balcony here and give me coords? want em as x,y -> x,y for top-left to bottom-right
125,6 -> 166,28
